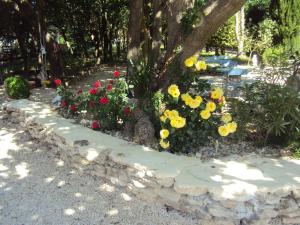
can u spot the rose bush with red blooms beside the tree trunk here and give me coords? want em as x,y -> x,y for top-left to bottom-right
57,71 -> 134,130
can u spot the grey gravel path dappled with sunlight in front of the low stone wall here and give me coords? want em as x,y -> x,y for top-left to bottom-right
0,103 -> 199,225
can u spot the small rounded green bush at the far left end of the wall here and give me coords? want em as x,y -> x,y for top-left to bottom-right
4,76 -> 30,99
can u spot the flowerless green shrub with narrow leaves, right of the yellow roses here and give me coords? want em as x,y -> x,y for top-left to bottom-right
231,82 -> 300,144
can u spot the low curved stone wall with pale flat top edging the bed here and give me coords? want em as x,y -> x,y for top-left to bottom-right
3,100 -> 300,225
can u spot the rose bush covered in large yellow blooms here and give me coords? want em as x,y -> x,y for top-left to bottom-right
160,57 -> 237,153
